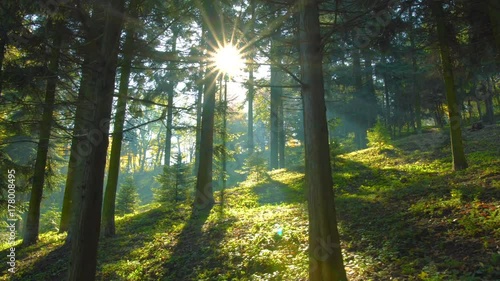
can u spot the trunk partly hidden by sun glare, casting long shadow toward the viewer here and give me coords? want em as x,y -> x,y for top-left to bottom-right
194,0 -> 221,209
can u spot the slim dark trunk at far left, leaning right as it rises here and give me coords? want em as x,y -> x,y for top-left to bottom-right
23,19 -> 64,245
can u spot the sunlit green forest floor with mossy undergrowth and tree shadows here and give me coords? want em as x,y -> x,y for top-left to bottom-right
0,126 -> 500,281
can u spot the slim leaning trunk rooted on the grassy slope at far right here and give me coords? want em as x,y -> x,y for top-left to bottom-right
430,0 -> 467,170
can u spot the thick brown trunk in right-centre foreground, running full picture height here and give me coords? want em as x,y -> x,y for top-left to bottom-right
299,0 -> 347,281
